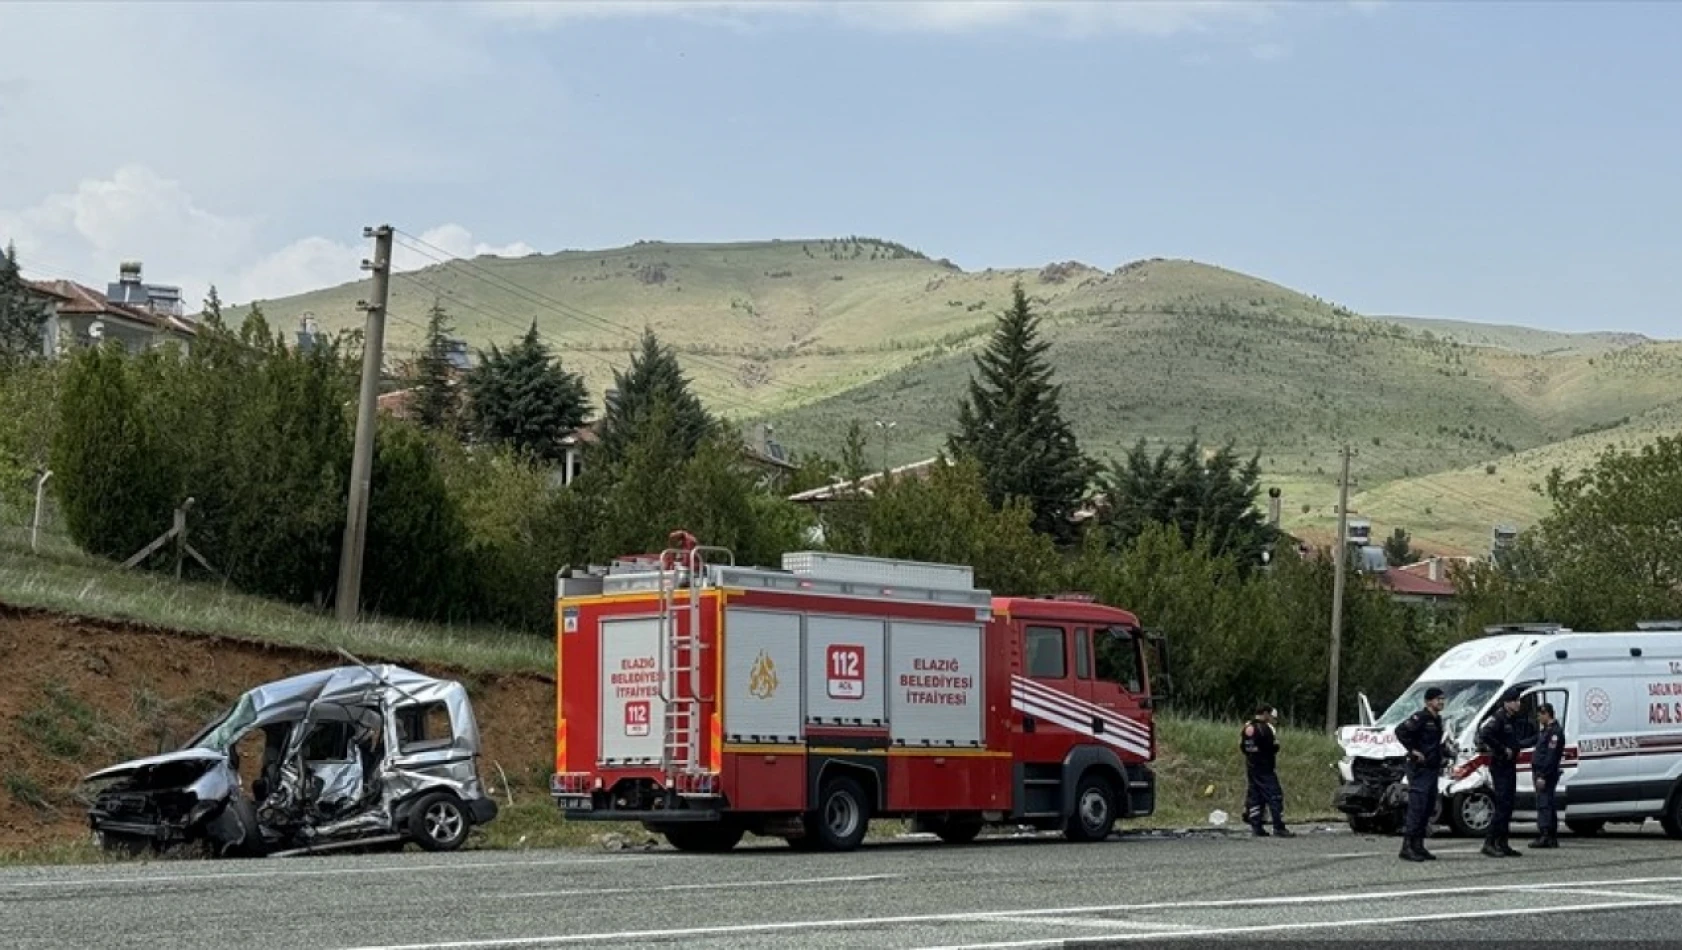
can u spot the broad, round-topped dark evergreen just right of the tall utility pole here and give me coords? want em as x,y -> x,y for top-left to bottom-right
468,321 -> 589,461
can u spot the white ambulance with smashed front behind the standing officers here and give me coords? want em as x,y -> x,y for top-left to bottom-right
1334,620 -> 1682,837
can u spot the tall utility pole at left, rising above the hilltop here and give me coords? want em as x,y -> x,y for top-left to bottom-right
338,224 -> 392,624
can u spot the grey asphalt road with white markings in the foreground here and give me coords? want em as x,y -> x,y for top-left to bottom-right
0,824 -> 1682,950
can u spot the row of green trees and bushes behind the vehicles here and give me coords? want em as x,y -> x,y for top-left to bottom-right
0,270 -> 1682,723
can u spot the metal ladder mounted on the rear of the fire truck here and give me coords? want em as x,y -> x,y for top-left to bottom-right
658,531 -> 735,795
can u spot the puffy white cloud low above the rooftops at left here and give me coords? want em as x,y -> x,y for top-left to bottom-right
0,165 -> 537,309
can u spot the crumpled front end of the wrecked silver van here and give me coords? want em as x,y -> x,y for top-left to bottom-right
84,748 -> 259,856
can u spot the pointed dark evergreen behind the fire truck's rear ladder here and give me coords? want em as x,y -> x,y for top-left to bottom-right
595,330 -> 720,464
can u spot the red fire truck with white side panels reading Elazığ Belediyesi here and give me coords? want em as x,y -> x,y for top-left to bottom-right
550,531 -> 1167,851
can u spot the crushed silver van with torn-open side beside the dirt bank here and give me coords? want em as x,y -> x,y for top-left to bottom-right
82,664 -> 496,856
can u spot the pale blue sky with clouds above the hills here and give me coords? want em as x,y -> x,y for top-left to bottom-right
0,0 -> 1682,338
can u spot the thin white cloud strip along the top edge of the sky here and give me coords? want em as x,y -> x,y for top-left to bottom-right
473,0 -> 1280,35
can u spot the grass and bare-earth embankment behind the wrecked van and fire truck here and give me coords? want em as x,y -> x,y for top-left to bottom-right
0,546 -> 1337,864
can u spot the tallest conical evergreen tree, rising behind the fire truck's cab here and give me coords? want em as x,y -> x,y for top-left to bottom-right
950,282 -> 1097,541
